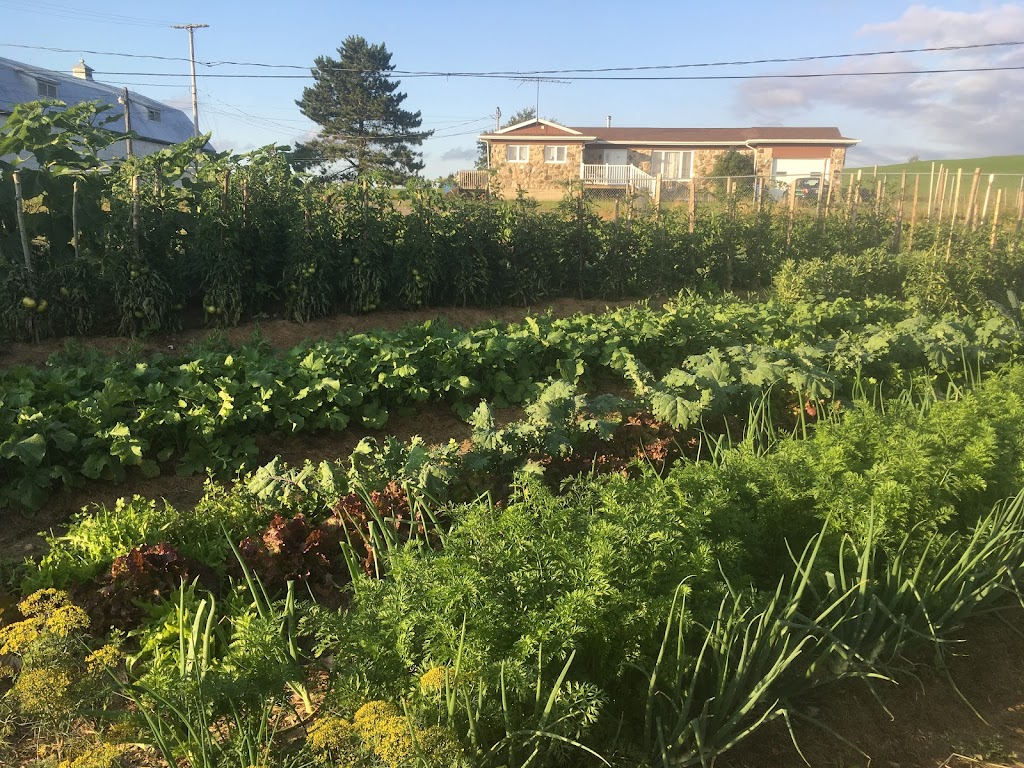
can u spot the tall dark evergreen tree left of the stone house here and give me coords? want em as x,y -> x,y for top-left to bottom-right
294,35 -> 432,183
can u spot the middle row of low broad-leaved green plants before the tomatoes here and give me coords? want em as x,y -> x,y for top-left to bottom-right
0,297 -> 1019,508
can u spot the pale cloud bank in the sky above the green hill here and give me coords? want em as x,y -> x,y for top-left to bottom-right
738,4 -> 1024,156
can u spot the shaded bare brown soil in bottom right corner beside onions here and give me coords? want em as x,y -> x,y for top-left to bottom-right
717,606 -> 1024,768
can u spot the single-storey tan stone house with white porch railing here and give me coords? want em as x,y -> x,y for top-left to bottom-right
479,119 -> 858,200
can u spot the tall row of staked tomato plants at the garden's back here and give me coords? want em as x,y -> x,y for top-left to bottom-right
0,103 -> 1024,339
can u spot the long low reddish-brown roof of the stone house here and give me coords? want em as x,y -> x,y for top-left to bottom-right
480,120 -> 859,146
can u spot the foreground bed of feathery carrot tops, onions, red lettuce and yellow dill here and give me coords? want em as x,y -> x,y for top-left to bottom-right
6,366 -> 1024,768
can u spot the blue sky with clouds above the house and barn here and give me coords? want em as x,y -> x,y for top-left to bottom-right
0,0 -> 1024,178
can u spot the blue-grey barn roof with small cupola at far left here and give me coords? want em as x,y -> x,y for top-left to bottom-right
0,57 -> 193,144
